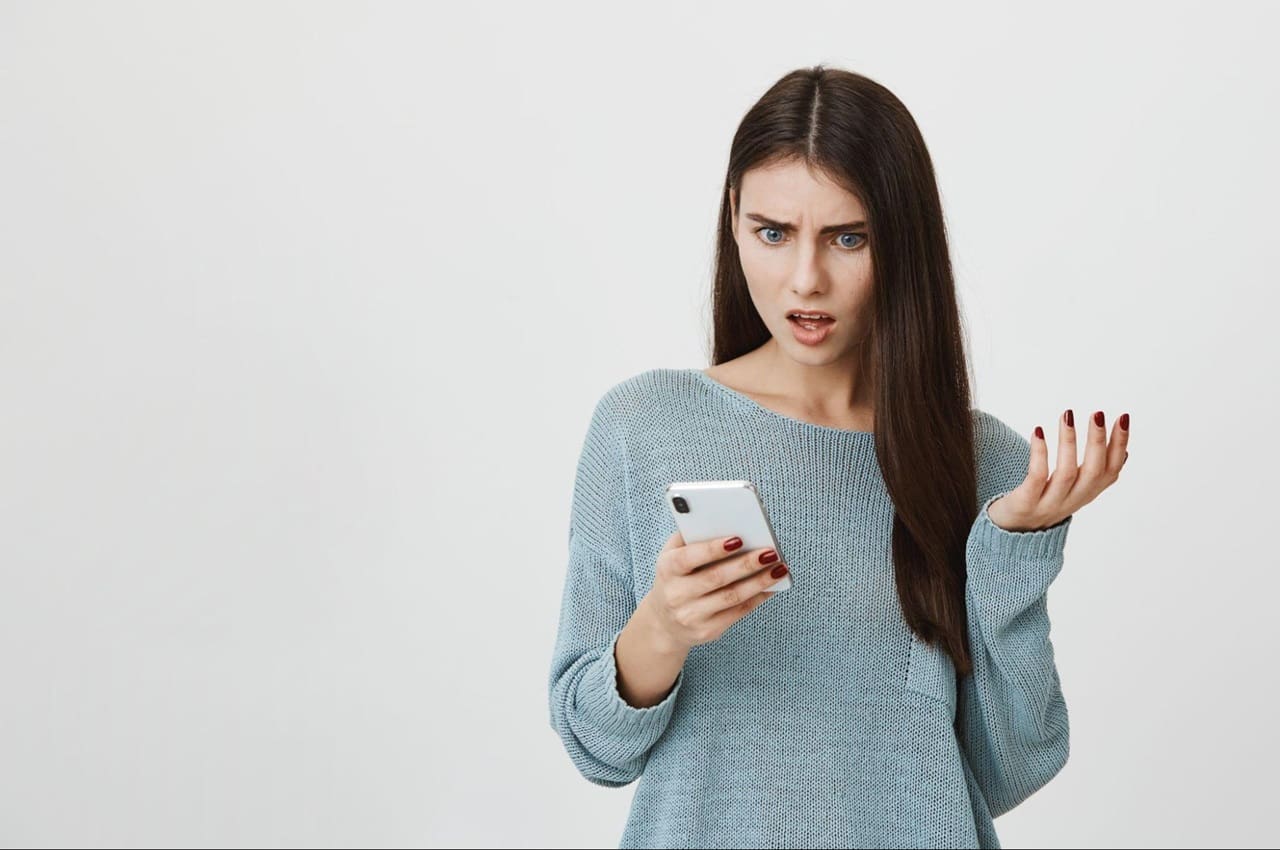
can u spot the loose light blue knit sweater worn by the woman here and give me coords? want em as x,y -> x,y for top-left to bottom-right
548,369 -> 1073,847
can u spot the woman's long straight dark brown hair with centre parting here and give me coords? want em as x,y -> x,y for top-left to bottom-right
712,65 -> 978,676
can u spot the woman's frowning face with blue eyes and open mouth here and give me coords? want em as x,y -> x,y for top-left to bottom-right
730,163 -> 873,365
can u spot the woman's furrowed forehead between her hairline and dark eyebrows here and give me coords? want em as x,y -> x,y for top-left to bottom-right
740,161 -> 867,218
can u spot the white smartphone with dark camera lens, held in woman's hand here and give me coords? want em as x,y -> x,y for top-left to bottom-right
666,481 -> 791,591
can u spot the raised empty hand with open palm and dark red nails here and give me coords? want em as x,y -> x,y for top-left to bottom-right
987,410 -> 1129,531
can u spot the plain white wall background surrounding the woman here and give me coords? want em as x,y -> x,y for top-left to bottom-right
0,1 -> 1280,847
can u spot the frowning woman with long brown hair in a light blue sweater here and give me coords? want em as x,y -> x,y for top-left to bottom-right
549,65 -> 1129,847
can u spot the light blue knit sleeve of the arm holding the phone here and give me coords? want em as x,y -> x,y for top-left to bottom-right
549,393 -> 685,787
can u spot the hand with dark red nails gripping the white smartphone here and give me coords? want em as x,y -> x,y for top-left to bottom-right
644,531 -> 787,652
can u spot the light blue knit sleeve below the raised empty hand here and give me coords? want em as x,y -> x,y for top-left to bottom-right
956,416 -> 1074,818
